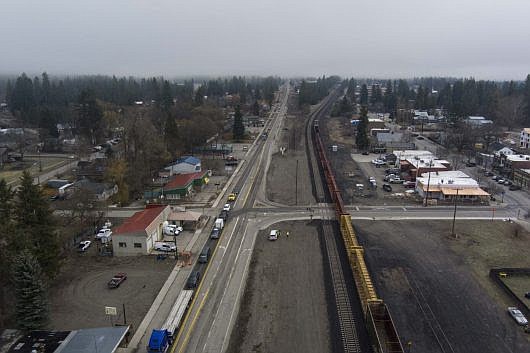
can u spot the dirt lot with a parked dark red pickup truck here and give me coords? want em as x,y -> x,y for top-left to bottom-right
50,247 -> 174,331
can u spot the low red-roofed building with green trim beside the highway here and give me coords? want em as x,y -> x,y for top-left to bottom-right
144,171 -> 209,202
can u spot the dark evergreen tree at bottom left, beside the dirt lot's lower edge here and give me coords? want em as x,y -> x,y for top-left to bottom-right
11,250 -> 48,331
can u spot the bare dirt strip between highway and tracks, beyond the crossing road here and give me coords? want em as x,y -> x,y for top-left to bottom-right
267,95 -> 315,206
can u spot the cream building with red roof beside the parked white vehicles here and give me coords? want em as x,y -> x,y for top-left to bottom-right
112,205 -> 171,256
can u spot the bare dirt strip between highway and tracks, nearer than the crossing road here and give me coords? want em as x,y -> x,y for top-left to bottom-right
228,221 -> 335,353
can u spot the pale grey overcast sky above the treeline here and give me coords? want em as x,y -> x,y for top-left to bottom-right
0,0 -> 530,79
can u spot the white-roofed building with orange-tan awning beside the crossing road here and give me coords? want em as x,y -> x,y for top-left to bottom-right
416,170 -> 490,202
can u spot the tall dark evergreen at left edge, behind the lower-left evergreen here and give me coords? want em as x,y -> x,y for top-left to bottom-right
14,171 -> 60,277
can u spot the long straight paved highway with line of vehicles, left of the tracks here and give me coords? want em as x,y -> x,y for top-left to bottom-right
173,85 -> 289,352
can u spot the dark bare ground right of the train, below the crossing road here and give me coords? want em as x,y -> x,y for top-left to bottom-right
355,221 -> 530,353
